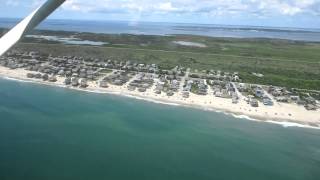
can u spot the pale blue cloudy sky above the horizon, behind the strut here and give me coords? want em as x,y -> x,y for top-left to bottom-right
0,0 -> 320,28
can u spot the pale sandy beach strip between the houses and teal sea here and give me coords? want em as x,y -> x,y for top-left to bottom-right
0,66 -> 320,127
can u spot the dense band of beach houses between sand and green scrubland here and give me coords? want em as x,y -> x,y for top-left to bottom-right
0,51 -> 317,109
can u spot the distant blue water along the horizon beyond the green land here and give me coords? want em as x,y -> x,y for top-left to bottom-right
0,18 -> 320,42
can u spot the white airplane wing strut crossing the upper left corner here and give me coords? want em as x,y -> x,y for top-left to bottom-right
0,0 -> 65,56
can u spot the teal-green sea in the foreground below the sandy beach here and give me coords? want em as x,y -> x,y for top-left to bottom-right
0,79 -> 320,180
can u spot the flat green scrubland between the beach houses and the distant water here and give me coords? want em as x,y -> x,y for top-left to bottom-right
13,31 -> 320,90
